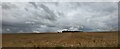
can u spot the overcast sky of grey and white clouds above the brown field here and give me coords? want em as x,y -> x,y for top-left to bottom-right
0,2 -> 118,33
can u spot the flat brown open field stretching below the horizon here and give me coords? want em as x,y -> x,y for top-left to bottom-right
2,32 -> 118,47
